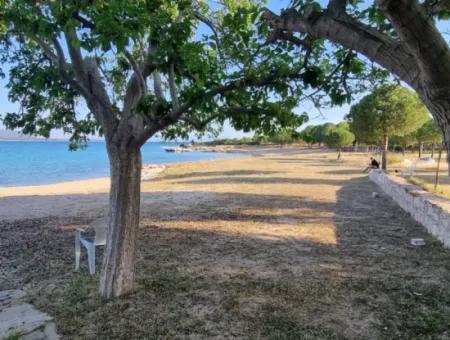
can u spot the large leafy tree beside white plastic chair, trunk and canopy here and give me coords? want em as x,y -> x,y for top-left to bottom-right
0,0 -> 316,298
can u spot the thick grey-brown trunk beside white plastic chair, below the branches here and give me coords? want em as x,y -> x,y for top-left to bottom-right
100,145 -> 142,298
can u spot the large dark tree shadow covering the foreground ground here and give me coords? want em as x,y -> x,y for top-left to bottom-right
0,178 -> 450,339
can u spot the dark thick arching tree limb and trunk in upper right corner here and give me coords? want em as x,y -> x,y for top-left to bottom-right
265,0 -> 450,175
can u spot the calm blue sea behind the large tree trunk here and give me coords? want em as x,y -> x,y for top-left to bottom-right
0,141 -> 236,187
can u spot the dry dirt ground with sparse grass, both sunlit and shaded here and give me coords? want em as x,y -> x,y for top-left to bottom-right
0,150 -> 450,339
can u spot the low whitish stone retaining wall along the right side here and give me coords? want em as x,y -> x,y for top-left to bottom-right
369,170 -> 450,248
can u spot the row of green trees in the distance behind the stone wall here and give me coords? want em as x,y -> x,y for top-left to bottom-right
300,84 -> 443,170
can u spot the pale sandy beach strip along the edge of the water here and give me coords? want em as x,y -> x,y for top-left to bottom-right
0,146 -> 304,221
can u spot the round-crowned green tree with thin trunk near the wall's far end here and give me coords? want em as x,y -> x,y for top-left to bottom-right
346,84 -> 428,170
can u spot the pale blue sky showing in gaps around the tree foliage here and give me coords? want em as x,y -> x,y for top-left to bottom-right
0,0 -> 442,138
